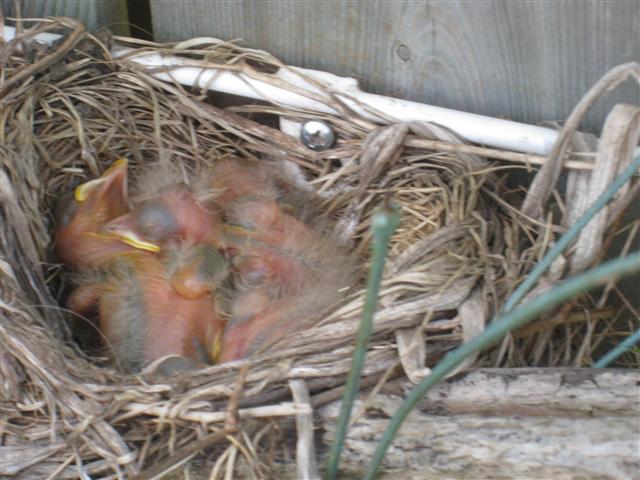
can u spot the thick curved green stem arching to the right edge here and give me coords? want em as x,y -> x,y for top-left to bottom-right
364,251 -> 640,480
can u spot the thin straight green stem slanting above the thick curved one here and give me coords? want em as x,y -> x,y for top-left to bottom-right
502,155 -> 640,313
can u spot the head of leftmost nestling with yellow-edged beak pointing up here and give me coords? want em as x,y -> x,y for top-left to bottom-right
54,158 -> 131,272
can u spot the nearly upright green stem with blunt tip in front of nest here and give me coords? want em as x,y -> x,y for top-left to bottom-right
327,205 -> 400,480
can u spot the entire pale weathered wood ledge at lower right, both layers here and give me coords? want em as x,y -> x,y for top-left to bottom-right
318,369 -> 640,479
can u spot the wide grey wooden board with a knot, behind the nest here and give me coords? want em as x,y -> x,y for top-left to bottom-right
151,0 -> 640,129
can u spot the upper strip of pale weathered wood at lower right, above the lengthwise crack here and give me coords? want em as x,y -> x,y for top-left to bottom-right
401,368 -> 640,416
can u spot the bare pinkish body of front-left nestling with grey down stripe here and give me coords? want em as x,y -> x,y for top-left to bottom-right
100,252 -> 225,372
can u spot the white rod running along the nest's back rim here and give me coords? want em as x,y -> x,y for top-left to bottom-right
2,25 -> 592,155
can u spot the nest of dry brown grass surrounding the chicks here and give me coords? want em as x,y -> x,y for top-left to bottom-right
0,19 -> 638,478
